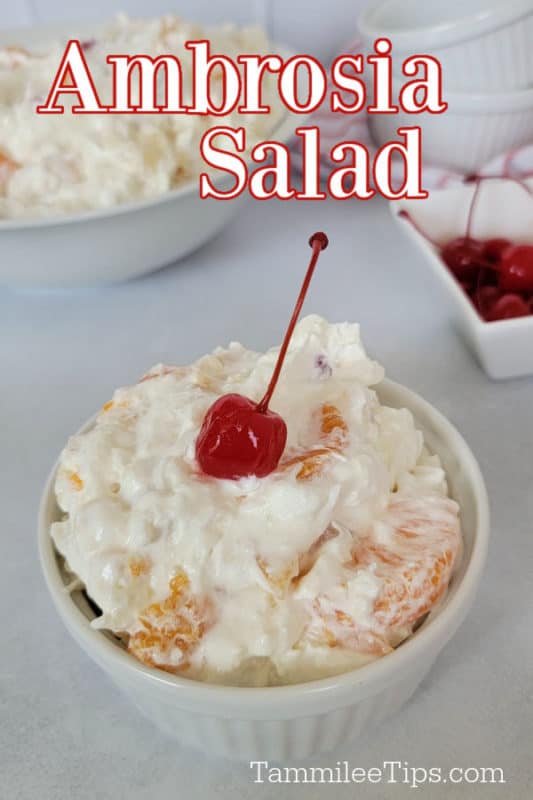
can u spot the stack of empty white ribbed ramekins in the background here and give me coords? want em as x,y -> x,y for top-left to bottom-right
359,0 -> 533,173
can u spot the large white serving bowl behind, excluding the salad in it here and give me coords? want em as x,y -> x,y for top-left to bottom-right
0,23 -> 296,287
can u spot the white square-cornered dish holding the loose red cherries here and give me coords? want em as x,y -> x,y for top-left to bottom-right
390,180 -> 533,379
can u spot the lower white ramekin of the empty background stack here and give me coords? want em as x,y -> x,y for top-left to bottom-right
369,78 -> 533,174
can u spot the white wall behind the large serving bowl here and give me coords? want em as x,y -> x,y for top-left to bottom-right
0,0 -> 365,58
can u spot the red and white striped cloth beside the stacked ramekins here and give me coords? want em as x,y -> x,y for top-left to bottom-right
291,39 -> 533,189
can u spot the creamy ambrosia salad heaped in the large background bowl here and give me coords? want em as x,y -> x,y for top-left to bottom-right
0,16 -> 283,218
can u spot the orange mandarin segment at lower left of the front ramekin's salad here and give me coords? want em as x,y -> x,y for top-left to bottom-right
128,572 -> 210,673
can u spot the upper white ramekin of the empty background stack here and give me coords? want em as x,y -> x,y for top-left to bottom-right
359,0 -> 533,92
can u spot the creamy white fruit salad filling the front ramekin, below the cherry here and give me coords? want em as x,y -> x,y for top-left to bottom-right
51,316 -> 460,685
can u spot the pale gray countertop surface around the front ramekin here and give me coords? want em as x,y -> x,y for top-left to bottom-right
0,195 -> 533,800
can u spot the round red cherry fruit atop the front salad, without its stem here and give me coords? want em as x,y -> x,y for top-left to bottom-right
196,394 -> 287,480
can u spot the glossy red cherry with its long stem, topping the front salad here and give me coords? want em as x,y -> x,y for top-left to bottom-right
196,233 -> 328,480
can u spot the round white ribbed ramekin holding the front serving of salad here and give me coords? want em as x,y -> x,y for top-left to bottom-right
39,381 -> 489,761
